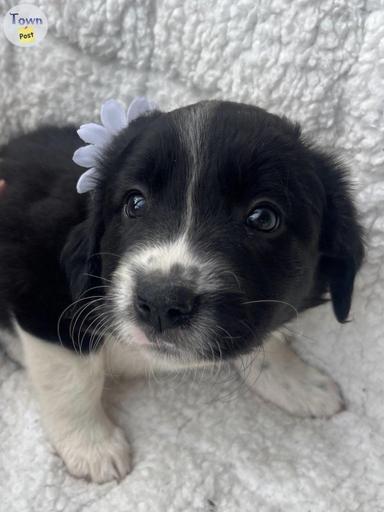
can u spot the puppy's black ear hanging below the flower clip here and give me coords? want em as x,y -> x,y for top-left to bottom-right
61,205 -> 103,299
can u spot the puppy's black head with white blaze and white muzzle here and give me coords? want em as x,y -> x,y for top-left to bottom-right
63,102 -> 363,359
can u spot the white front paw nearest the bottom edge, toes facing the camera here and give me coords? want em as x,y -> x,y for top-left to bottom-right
55,424 -> 131,483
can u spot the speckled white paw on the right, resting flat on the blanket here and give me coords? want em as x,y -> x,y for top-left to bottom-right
256,359 -> 344,418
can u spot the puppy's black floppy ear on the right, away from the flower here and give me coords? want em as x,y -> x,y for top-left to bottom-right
317,154 -> 364,322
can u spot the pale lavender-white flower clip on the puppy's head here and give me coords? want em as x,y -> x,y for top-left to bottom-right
72,97 -> 158,194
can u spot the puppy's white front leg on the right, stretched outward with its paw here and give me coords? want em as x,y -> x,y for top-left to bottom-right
235,333 -> 344,417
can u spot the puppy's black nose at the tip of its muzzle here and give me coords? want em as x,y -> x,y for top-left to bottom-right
135,282 -> 198,332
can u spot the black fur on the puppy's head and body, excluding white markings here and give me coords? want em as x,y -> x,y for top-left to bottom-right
0,102 -> 363,357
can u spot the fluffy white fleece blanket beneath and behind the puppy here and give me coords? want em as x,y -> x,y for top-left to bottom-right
0,0 -> 384,512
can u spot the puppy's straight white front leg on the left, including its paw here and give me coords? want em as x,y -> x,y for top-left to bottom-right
18,328 -> 130,483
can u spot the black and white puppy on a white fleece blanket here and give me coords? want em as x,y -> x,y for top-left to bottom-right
0,101 -> 363,482
